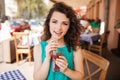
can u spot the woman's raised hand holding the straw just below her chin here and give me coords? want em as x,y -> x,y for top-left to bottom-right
46,40 -> 57,59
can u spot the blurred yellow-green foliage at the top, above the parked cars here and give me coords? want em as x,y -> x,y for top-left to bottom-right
18,0 -> 48,19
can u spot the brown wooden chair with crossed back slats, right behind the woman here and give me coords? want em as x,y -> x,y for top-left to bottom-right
83,50 -> 110,80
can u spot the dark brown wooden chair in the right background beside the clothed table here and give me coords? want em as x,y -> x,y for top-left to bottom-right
89,31 -> 110,56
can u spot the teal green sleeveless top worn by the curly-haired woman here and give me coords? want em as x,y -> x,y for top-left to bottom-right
40,41 -> 74,80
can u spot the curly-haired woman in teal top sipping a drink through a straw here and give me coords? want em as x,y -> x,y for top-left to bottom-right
34,2 -> 84,80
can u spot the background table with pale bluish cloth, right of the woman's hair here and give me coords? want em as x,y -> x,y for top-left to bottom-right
80,33 -> 100,45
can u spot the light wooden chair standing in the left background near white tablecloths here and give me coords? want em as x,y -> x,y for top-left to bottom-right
13,32 -> 33,64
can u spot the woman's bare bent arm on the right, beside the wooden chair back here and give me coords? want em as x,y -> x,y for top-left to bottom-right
64,48 -> 84,80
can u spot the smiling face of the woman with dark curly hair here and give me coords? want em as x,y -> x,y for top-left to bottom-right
49,11 -> 70,39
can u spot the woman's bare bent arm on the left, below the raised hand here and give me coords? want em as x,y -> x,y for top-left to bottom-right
34,45 -> 50,80
